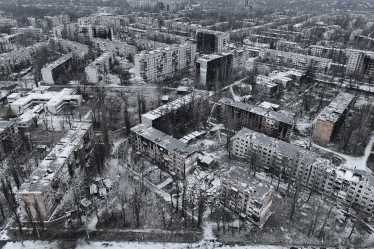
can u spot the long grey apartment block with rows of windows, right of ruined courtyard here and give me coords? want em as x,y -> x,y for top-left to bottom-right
231,128 -> 330,187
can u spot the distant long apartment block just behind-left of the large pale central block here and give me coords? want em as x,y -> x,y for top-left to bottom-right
92,38 -> 137,58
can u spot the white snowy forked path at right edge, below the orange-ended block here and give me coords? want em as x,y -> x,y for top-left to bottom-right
313,132 -> 374,172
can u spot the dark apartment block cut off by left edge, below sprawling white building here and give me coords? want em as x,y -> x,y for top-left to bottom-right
0,120 -> 21,160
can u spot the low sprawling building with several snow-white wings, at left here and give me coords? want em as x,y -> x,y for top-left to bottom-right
8,88 -> 82,115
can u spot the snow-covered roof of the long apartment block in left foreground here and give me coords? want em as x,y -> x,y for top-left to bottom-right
17,123 -> 92,194
